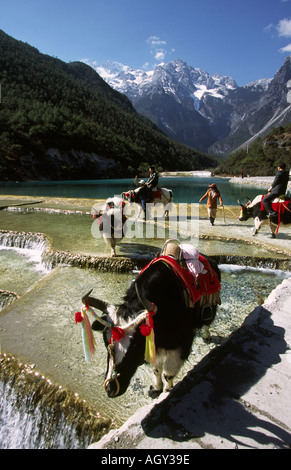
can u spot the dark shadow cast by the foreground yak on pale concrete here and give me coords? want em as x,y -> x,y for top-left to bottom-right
141,307 -> 291,448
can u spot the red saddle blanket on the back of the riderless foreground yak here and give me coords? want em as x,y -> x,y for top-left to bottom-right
141,255 -> 221,305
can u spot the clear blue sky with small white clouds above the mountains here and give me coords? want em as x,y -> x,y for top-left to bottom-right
0,0 -> 291,86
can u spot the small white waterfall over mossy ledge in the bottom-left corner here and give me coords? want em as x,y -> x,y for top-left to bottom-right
0,354 -> 112,449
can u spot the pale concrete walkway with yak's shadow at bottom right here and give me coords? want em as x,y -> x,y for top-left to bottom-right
90,278 -> 291,453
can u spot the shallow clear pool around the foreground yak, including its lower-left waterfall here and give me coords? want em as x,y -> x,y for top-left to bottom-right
0,239 -> 290,448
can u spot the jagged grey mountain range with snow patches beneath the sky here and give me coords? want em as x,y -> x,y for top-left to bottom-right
89,57 -> 291,155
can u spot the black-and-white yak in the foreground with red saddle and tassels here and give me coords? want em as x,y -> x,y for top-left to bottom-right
76,242 -> 221,398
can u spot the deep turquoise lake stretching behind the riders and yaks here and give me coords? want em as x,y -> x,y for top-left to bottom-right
0,176 -> 266,205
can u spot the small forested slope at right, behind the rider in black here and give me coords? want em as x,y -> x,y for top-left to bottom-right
214,124 -> 291,176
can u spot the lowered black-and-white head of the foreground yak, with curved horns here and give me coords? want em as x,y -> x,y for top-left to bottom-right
82,291 -> 153,398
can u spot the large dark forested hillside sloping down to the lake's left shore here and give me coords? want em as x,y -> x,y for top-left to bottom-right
0,30 -> 216,180
